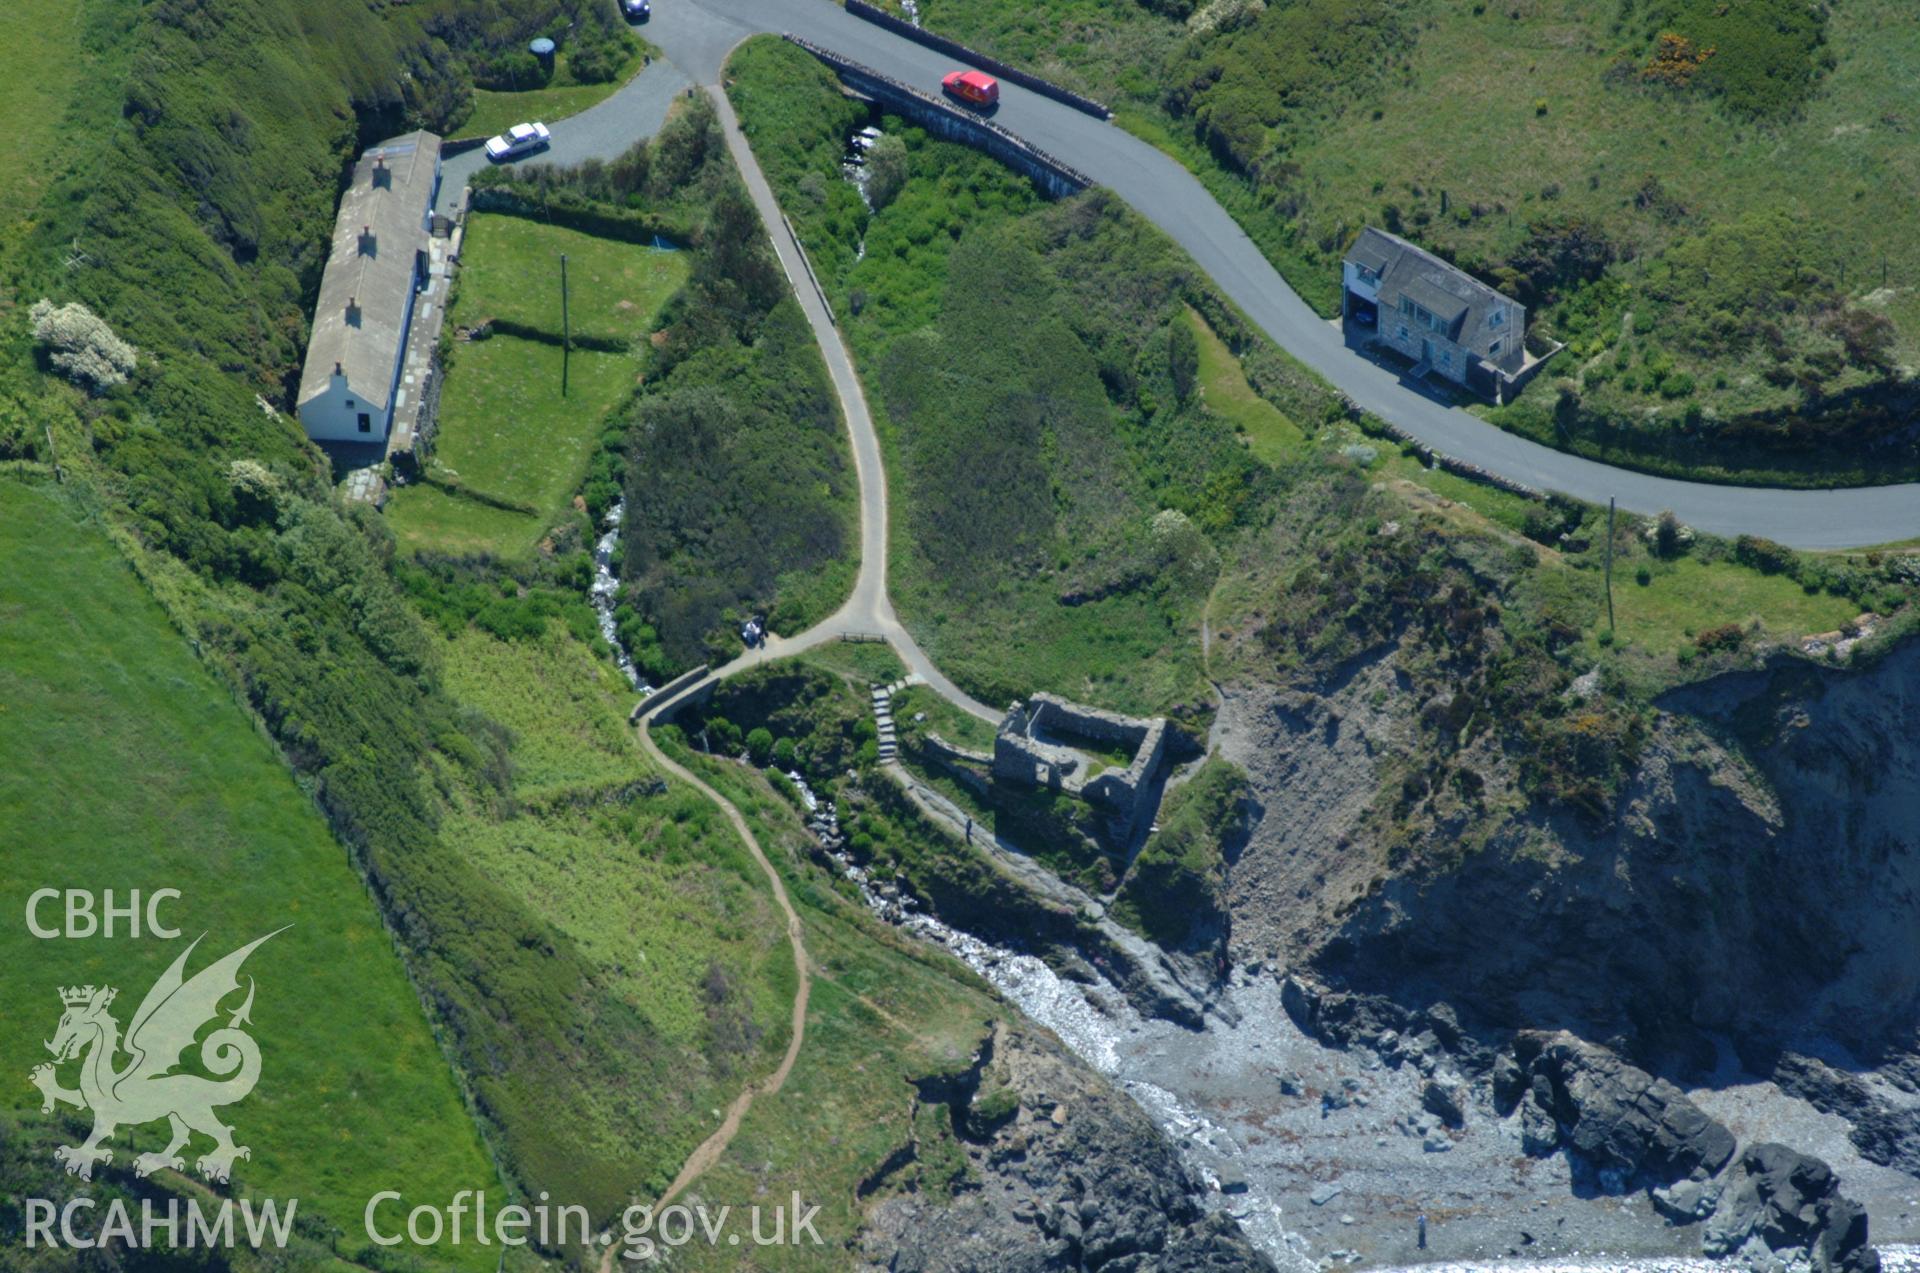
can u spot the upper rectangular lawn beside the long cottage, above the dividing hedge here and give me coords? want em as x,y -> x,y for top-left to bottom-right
453,213 -> 689,342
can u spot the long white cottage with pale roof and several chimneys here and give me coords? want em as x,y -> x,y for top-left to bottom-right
298,132 -> 440,442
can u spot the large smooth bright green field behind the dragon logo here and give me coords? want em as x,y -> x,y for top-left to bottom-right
0,480 -> 497,1269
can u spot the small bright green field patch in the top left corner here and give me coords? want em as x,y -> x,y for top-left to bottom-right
0,0 -> 84,229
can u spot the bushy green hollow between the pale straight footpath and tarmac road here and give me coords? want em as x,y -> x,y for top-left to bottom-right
730,40 -> 1233,709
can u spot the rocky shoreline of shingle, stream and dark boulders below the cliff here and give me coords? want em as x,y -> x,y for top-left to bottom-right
787,656 -> 1920,1273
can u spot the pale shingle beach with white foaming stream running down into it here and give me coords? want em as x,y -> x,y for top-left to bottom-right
789,774 -> 1920,1273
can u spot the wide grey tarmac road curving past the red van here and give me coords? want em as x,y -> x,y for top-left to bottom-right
468,0 -> 1920,549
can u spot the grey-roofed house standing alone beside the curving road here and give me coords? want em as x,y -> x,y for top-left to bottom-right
1340,227 -> 1538,401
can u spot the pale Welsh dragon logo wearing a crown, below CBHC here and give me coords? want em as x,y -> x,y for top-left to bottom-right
27,929 -> 286,1183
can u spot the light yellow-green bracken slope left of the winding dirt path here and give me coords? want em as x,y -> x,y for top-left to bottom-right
428,624 -> 793,1196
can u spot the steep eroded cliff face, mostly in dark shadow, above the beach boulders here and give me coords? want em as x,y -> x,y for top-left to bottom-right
1219,643 -> 1920,1071
